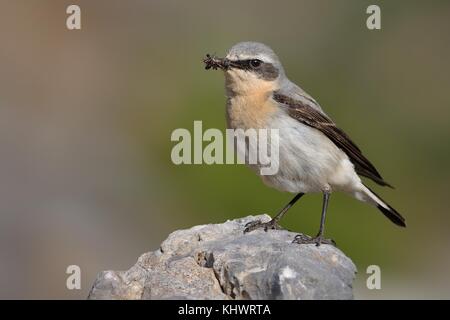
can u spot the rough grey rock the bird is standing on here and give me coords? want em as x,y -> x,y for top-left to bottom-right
88,215 -> 356,299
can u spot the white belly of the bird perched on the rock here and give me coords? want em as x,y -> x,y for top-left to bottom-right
232,112 -> 360,193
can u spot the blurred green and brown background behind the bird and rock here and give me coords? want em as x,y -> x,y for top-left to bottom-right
0,0 -> 450,299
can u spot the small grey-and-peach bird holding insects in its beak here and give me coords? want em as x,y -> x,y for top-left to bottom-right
203,42 -> 406,246
